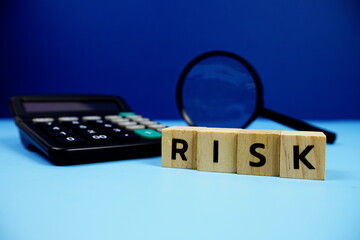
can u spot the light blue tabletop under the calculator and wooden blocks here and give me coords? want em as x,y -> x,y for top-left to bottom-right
0,119 -> 360,240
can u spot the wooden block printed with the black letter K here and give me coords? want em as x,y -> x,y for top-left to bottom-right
280,131 -> 326,180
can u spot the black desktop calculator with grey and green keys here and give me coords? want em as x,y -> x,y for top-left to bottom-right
10,95 -> 166,165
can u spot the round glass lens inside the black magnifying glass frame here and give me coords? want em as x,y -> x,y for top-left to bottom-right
182,56 -> 258,128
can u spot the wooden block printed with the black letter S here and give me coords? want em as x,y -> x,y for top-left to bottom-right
237,130 -> 280,176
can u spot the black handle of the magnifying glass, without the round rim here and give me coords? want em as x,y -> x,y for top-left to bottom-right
261,108 -> 336,143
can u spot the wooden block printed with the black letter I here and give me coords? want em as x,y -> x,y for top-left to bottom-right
197,128 -> 239,173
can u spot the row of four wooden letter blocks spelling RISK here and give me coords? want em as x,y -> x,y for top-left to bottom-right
162,127 -> 326,180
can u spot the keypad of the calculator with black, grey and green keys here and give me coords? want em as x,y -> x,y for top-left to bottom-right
33,113 -> 166,146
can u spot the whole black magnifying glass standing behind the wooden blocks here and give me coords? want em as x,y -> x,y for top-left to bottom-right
176,51 -> 336,143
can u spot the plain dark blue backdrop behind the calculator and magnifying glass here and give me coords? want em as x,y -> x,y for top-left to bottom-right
0,0 -> 360,119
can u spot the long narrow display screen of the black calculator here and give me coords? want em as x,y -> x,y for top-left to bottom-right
24,102 -> 119,113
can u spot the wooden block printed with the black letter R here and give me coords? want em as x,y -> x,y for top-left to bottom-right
161,127 -> 202,169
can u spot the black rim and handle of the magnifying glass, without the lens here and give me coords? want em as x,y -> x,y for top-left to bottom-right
176,51 -> 336,143
